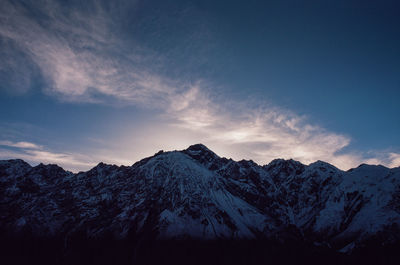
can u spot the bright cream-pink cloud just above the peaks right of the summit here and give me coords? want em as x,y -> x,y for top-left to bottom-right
166,93 -> 359,169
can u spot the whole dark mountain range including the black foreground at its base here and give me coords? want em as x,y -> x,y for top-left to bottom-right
0,144 -> 400,264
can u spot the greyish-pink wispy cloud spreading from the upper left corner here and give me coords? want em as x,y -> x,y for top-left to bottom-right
0,1 -> 186,106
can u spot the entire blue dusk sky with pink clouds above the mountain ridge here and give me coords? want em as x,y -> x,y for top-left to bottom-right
0,0 -> 400,171
